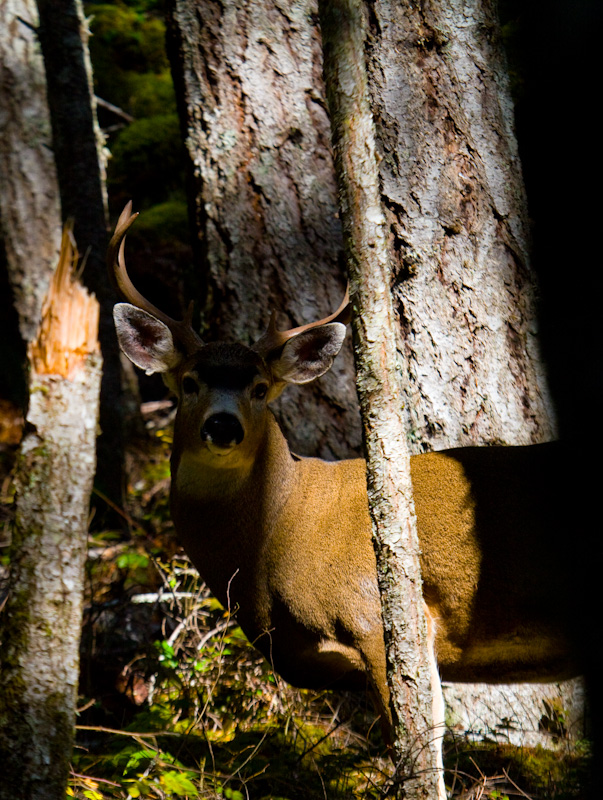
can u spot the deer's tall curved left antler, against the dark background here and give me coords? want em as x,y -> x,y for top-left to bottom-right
107,201 -> 203,353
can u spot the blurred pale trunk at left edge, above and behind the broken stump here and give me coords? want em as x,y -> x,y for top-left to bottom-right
0,0 -> 61,342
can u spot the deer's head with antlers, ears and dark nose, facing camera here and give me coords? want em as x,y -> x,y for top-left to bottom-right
108,203 -> 350,463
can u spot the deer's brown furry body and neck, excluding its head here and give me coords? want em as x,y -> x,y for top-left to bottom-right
172,404 -> 577,716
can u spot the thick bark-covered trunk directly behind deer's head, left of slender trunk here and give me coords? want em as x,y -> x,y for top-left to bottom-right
170,0 -> 361,458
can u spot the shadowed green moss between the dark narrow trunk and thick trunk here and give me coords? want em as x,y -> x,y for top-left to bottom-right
85,0 -> 185,210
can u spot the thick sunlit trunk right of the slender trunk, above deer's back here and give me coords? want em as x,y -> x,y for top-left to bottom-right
369,0 -> 555,450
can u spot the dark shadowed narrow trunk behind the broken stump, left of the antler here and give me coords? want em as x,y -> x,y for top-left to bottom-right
37,0 -> 124,512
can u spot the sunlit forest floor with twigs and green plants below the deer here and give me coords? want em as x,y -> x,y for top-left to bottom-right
0,402 -> 588,800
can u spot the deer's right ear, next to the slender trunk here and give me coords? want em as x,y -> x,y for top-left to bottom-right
271,322 -> 345,383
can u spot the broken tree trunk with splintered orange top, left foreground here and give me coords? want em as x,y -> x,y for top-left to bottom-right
0,223 -> 101,800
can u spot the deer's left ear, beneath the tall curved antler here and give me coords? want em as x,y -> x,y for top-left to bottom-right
113,303 -> 182,375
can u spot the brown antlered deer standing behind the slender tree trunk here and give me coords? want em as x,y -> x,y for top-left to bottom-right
108,203 -> 580,800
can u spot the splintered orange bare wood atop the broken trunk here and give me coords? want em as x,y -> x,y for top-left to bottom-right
28,223 -> 99,378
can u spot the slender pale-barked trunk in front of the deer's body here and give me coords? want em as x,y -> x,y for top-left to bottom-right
319,0 -> 438,798
